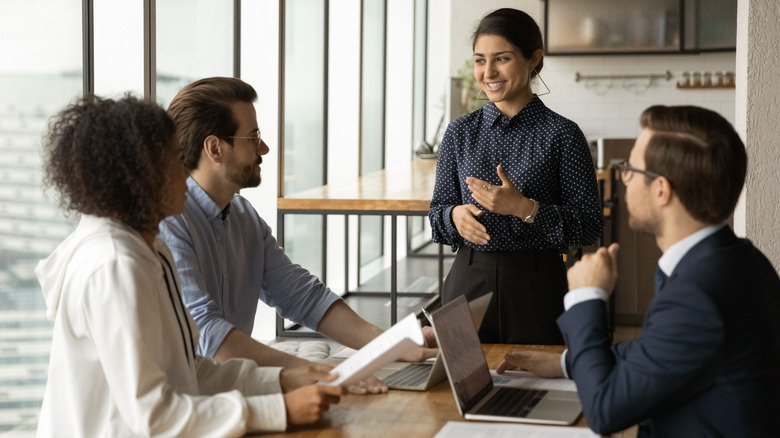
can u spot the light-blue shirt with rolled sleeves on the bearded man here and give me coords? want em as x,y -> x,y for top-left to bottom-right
159,177 -> 340,357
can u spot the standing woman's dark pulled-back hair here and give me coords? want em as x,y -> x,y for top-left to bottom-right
471,8 -> 544,76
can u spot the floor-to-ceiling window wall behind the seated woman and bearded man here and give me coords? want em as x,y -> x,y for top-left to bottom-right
0,0 -> 436,436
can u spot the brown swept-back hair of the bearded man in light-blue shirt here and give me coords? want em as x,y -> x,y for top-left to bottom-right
168,77 -> 257,170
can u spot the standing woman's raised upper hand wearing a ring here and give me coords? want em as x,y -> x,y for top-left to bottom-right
466,164 -> 534,218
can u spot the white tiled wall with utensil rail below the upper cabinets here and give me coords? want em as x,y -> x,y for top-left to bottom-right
534,52 -> 740,138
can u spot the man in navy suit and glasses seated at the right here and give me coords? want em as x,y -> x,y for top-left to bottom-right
499,106 -> 780,437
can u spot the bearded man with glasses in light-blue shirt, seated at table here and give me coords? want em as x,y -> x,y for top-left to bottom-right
160,77 -> 437,392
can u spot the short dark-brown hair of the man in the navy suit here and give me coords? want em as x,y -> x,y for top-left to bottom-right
640,105 -> 747,224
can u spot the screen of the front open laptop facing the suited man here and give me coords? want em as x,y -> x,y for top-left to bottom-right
431,296 -> 493,412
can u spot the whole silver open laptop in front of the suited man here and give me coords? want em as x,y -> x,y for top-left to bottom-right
425,297 -> 582,425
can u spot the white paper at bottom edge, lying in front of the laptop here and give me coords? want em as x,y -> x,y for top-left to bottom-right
435,421 -> 601,438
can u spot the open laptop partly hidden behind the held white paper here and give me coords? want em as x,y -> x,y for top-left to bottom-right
375,292 -> 493,391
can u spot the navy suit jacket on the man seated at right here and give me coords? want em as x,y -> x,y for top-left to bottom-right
558,227 -> 780,437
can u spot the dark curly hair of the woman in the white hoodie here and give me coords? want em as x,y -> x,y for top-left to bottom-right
43,94 -> 176,234
